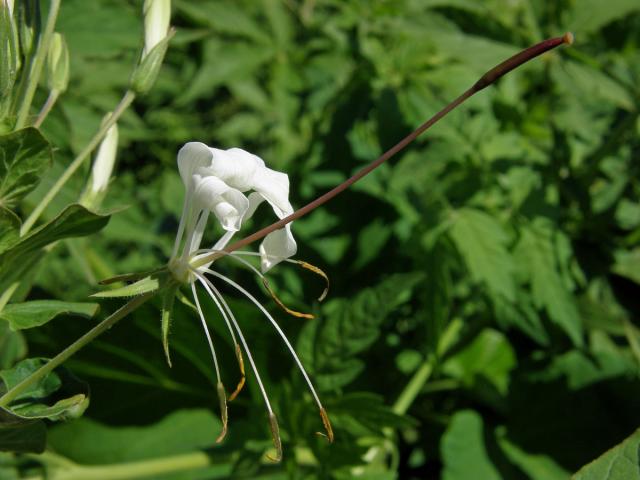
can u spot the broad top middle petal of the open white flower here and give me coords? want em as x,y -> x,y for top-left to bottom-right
206,148 -> 264,192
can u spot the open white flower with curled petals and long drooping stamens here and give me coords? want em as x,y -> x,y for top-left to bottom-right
169,142 -> 333,460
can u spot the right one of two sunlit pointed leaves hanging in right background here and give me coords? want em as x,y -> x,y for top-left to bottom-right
516,222 -> 583,346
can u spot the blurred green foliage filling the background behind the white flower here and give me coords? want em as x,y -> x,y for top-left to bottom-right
0,0 -> 640,480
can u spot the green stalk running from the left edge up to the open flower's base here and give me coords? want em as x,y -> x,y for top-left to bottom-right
0,292 -> 155,407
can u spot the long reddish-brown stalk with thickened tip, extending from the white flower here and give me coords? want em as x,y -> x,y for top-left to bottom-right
225,33 -> 573,252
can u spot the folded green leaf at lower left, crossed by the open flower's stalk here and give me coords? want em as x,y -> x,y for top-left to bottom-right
0,358 -> 89,421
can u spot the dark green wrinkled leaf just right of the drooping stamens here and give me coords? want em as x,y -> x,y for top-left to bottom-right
298,273 -> 423,390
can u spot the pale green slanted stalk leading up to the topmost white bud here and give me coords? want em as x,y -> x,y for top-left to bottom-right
20,90 -> 136,235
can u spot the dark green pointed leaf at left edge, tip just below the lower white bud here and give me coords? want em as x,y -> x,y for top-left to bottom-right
0,205 -> 109,290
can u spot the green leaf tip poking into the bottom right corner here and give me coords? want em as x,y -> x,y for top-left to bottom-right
571,429 -> 640,480
